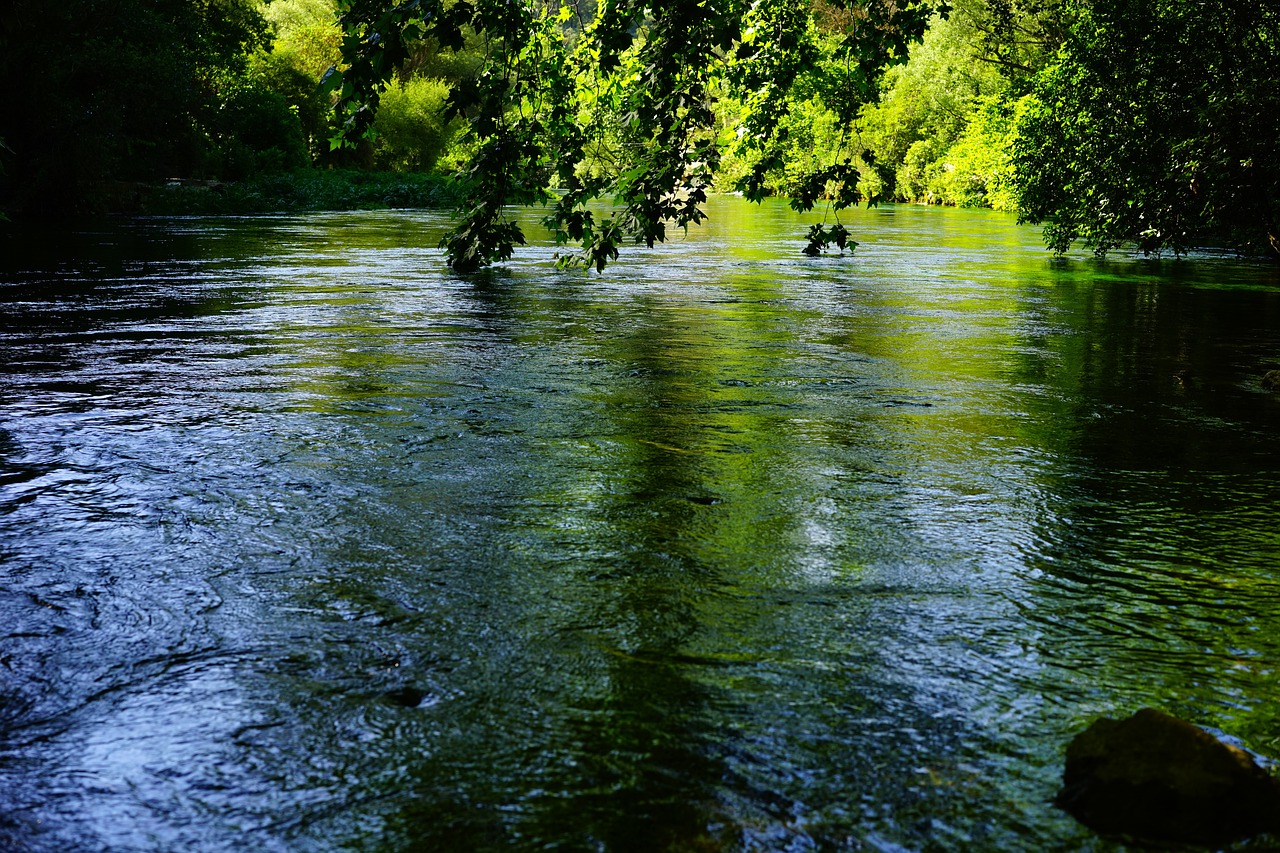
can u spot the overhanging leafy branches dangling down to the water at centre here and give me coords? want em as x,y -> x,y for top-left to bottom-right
330,0 -> 947,272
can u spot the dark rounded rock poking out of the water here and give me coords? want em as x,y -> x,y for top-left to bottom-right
1053,708 -> 1280,847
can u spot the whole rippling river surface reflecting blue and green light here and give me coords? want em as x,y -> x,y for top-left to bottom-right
0,199 -> 1280,853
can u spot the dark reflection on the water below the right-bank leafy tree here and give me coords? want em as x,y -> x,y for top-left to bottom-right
1027,265 -> 1280,469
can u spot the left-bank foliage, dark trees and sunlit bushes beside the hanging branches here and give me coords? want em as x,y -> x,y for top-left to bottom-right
0,0 -> 474,216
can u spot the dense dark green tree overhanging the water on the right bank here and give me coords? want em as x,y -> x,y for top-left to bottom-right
1015,0 -> 1280,257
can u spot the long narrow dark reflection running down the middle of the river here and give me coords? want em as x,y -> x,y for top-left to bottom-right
494,280 -> 793,850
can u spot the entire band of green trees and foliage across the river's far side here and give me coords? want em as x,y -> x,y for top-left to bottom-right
0,0 -> 1280,270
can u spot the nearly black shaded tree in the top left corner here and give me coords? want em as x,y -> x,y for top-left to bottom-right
0,0 -> 268,214
